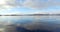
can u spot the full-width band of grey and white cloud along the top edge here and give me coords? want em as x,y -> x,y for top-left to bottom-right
0,0 -> 60,10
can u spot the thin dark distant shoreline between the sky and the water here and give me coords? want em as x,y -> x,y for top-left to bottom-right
0,14 -> 60,16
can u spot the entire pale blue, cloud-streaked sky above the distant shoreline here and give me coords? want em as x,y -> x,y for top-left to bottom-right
0,0 -> 60,14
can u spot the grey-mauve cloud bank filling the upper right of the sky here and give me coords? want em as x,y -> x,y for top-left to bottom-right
23,0 -> 60,9
